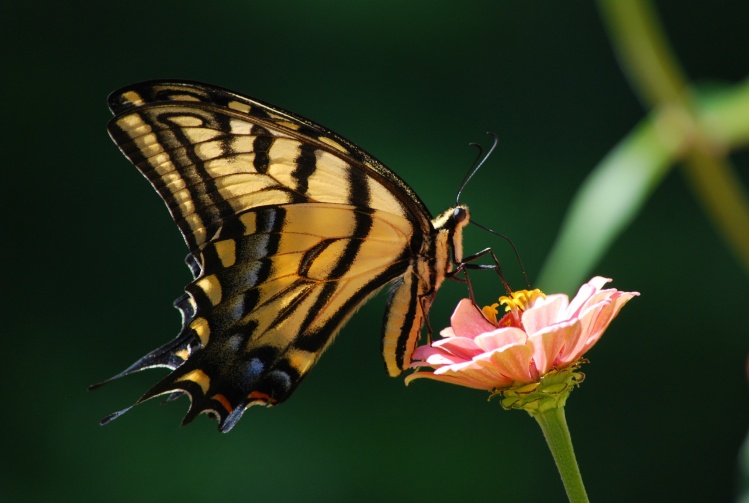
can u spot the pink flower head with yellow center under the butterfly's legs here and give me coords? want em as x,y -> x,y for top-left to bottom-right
406,276 -> 639,392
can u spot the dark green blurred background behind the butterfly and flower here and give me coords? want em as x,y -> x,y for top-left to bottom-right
0,0 -> 749,502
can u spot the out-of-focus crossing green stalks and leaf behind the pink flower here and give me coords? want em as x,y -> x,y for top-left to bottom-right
538,0 -> 749,291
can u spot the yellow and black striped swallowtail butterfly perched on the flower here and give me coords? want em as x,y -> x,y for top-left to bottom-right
92,80 -> 469,432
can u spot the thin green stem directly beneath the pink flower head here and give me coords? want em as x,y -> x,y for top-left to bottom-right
532,407 -> 588,503
